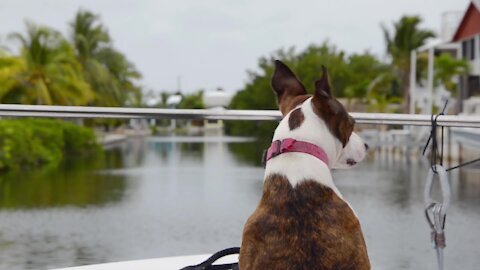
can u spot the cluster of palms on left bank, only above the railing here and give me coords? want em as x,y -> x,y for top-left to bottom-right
0,10 -> 141,106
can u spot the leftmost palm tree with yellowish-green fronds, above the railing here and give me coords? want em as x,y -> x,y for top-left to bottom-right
0,23 -> 93,105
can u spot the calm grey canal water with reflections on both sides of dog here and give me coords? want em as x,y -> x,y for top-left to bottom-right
0,136 -> 480,270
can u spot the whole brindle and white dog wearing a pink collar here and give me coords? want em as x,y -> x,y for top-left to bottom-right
239,61 -> 370,270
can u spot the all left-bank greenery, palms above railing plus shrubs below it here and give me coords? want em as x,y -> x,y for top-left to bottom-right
0,10 -> 142,171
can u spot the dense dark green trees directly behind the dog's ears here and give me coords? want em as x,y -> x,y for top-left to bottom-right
227,42 -> 390,137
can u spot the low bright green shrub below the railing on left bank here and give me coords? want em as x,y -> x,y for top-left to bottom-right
0,119 -> 100,171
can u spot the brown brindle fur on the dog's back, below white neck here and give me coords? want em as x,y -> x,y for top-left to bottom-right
240,175 -> 370,270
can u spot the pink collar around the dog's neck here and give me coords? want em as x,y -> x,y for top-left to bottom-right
264,138 -> 328,166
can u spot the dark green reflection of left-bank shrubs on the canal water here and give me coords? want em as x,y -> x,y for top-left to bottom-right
0,151 -> 126,210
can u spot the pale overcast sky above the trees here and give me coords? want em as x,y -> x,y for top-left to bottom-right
0,0 -> 469,92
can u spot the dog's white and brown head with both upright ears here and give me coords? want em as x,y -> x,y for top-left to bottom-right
272,60 -> 368,169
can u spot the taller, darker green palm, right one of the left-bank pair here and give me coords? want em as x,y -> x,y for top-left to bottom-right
70,10 -> 141,106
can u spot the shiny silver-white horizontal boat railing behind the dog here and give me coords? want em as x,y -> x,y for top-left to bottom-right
0,104 -> 480,128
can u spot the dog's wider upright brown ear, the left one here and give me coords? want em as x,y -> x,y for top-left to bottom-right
272,60 -> 307,114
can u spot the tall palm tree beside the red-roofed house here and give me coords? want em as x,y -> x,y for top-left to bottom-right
382,16 -> 435,112
